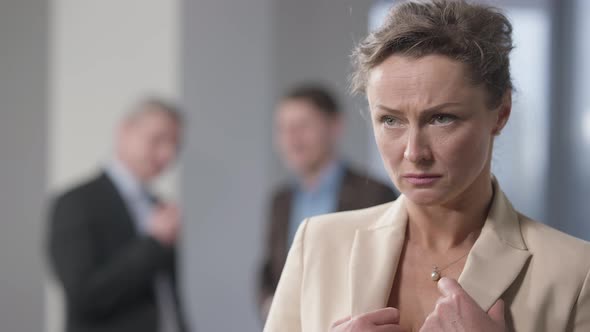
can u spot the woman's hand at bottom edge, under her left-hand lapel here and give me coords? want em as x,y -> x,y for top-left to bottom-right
330,308 -> 410,332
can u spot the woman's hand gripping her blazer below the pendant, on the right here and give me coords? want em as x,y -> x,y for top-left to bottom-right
420,278 -> 506,332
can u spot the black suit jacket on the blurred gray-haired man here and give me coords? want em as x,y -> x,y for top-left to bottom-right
48,173 -> 186,332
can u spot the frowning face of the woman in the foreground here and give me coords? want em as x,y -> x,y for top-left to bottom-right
367,55 -> 510,205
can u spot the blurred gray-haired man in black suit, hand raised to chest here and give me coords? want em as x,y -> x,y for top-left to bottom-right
48,98 -> 187,332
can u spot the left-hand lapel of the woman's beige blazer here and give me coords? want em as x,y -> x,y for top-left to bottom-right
349,199 -> 408,316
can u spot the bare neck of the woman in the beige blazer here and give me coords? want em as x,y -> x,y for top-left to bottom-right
407,172 -> 493,252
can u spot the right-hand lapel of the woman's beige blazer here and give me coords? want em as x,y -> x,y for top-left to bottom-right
459,184 -> 531,311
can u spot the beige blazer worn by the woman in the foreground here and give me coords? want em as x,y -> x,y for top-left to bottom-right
264,183 -> 590,332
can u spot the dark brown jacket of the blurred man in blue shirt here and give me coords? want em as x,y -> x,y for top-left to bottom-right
258,168 -> 397,304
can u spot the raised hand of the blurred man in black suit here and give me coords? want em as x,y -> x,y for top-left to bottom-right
148,203 -> 180,246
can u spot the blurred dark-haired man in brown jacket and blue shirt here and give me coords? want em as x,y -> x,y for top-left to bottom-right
258,84 -> 396,319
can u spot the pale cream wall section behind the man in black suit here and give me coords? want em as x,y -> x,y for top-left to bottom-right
48,0 -> 180,332
